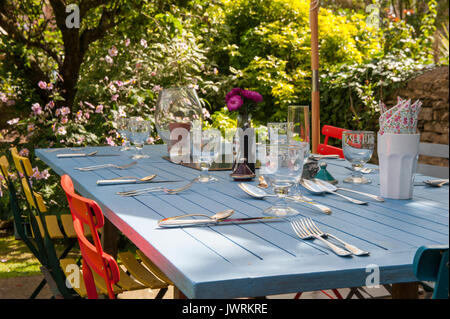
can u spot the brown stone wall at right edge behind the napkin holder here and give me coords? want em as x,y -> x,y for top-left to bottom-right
387,67 -> 449,166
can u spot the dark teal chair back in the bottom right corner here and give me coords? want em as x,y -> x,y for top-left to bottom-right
413,245 -> 449,299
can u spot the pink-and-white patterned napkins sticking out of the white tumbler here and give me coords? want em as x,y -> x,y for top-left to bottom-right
379,97 -> 422,135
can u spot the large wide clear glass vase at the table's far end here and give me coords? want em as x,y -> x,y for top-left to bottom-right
155,87 -> 203,158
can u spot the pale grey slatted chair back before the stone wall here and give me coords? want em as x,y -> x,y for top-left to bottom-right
417,143 -> 449,178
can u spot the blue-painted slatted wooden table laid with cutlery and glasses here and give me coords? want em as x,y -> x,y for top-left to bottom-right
36,145 -> 449,298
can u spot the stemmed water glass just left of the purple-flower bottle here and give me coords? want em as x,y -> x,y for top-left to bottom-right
193,129 -> 222,183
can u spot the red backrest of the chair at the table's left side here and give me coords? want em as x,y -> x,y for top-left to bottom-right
61,175 -> 120,299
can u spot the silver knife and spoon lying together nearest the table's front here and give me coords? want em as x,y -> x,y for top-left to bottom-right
158,209 -> 283,228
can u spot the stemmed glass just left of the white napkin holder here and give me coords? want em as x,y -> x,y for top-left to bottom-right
342,131 -> 375,184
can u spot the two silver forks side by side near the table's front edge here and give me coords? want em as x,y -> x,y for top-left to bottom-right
291,217 -> 370,257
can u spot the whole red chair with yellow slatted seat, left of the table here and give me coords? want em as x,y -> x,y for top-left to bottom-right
61,175 -> 168,299
